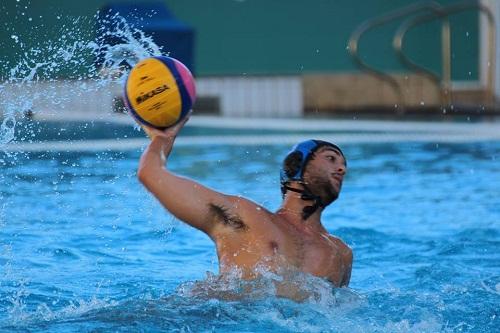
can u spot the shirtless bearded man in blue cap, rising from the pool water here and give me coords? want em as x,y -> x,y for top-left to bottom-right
138,117 -> 352,287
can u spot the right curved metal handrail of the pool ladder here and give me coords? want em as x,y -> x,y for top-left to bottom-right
393,0 -> 496,105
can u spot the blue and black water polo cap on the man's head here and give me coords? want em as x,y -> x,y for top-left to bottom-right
280,140 -> 345,194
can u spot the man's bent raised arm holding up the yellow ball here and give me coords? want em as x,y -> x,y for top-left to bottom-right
137,119 -> 233,237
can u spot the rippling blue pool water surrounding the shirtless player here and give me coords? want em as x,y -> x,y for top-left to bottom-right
0,142 -> 500,333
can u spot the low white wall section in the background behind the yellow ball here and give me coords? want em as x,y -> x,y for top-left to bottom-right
0,76 -> 303,118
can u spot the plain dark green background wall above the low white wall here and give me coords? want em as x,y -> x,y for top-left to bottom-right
0,0 -> 478,80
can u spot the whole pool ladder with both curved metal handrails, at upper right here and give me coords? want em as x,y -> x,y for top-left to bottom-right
348,0 -> 496,113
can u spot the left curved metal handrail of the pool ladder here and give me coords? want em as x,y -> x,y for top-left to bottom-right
348,1 -> 442,113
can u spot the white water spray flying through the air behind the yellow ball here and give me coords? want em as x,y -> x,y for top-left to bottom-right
0,13 -> 162,149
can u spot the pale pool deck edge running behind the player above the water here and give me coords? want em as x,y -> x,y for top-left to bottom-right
0,113 -> 500,151
